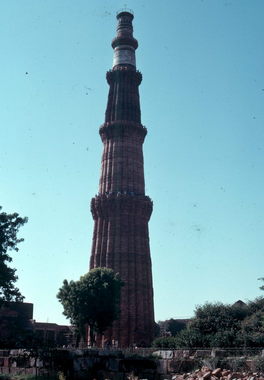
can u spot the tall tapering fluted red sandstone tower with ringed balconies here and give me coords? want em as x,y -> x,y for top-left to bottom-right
90,10 -> 154,347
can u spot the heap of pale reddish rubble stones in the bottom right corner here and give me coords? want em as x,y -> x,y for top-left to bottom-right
172,366 -> 264,380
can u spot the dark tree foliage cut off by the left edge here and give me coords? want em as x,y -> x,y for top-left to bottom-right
0,207 -> 27,304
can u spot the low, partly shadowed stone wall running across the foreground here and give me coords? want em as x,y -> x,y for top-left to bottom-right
0,349 -> 264,380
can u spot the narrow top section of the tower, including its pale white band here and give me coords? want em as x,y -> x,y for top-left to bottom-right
112,9 -> 138,68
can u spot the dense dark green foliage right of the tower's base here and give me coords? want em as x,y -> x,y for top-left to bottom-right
153,297 -> 264,348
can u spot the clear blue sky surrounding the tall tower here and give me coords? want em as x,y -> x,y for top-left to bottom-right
0,0 -> 264,323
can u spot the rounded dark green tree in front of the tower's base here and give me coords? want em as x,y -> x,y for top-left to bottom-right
57,268 -> 123,345
